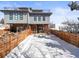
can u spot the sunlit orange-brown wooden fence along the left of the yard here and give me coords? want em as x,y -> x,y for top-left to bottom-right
0,29 -> 32,58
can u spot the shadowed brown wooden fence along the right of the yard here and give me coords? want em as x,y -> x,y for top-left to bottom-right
50,30 -> 79,47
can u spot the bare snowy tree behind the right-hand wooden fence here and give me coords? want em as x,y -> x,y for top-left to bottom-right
60,21 -> 79,33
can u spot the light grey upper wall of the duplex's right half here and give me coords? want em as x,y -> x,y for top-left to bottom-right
28,15 -> 50,24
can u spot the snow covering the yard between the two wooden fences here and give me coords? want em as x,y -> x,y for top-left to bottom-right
5,34 -> 79,58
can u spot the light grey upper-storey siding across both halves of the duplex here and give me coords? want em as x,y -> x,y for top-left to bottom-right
4,12 -> 50,24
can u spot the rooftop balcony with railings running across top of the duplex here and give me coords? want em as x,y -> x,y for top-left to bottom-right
3,7 -> 52,13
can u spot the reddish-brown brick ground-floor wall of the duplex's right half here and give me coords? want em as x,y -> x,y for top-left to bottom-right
30,24 -> 48,33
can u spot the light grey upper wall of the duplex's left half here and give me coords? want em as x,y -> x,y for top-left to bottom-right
4,12 -> 27,24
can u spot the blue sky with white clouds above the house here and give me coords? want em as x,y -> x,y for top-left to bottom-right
0,1 -> 79,28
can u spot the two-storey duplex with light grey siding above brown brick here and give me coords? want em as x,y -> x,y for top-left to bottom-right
0,7 -> 52,32
